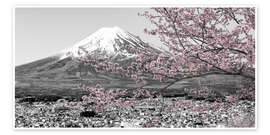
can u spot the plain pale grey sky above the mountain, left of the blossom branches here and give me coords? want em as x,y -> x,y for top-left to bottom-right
15,8 -> 161,65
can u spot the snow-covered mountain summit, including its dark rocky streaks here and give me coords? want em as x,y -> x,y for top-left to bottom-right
60,27 -> 152,59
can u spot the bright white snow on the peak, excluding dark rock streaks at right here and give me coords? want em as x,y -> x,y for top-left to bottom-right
60,26 -> 141,59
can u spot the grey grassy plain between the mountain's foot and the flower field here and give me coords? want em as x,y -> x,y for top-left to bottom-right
15,75 -> 246,99
